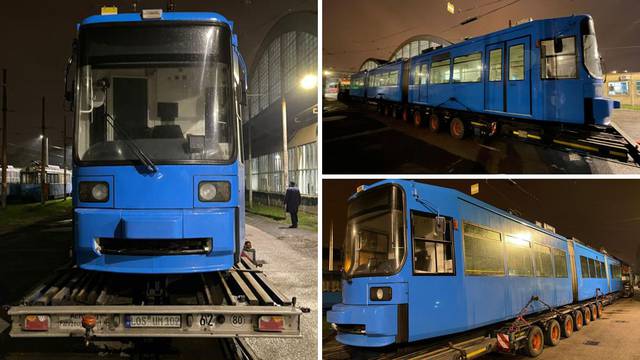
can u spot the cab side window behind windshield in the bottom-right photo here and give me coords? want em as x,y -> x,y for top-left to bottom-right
411,212 -> 454,274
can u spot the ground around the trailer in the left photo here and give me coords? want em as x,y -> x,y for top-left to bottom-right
0,216 -> 317,360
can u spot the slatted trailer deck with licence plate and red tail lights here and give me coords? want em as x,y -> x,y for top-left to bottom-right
7,258 -> 307,341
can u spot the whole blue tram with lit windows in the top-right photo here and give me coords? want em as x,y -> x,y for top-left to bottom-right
352,15 -> 619,138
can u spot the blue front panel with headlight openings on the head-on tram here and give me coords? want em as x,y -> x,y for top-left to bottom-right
73,163 -> 244,273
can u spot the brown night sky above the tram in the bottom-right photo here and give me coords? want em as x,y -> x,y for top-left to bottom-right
322,179 -> 640,271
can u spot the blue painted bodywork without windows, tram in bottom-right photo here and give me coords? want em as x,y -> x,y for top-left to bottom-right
327,180 -> 620,346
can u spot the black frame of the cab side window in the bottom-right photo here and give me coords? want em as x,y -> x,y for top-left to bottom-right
411,210 -> 456,276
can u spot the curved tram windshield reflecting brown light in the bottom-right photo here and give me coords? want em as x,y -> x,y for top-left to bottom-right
344,186 -> 406,277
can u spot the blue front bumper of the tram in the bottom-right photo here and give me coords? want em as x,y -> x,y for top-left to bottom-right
327,304 -> 398,347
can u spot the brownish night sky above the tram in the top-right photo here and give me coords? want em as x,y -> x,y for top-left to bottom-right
323,0 -> 640,72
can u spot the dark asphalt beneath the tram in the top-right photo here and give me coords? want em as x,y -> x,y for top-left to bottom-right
322,101 -> 640,174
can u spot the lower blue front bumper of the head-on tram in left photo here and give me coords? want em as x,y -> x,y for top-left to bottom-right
74,207 -> 238,274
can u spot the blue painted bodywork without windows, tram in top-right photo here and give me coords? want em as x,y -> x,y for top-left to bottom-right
356,15 -> 619,126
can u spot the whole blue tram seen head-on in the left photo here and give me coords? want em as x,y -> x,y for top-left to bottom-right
66,10 -> 246,274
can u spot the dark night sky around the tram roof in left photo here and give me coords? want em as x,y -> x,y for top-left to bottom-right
0,0 -> 317,164
